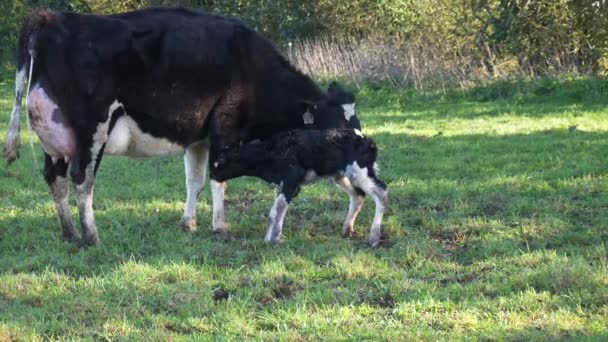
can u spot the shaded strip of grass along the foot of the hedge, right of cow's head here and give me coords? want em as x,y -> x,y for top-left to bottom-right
359,79 -> 608,122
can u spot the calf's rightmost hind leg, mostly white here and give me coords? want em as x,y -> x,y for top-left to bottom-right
347,163 -> 388,247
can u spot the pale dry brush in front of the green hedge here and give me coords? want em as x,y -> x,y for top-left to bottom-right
287,37 -> 590,90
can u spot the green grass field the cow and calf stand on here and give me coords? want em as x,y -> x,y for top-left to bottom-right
0,76 -> 608,341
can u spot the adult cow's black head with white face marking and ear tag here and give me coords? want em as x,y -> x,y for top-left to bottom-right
302,82 -> 361,130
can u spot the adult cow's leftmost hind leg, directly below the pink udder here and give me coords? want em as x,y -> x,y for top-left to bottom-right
44,153 -> 78,242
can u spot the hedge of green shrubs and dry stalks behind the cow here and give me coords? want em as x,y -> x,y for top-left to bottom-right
0,0 -> 608,88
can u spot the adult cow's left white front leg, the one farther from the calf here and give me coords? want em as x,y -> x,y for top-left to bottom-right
180,142 -> 209,232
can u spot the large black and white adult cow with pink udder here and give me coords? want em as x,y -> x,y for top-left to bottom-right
4,8 -> 359,244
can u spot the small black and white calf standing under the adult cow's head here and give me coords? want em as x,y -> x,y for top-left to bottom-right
213,129 -> 387,247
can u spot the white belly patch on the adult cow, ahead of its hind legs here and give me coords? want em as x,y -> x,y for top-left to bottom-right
105,101 -> 184,157
